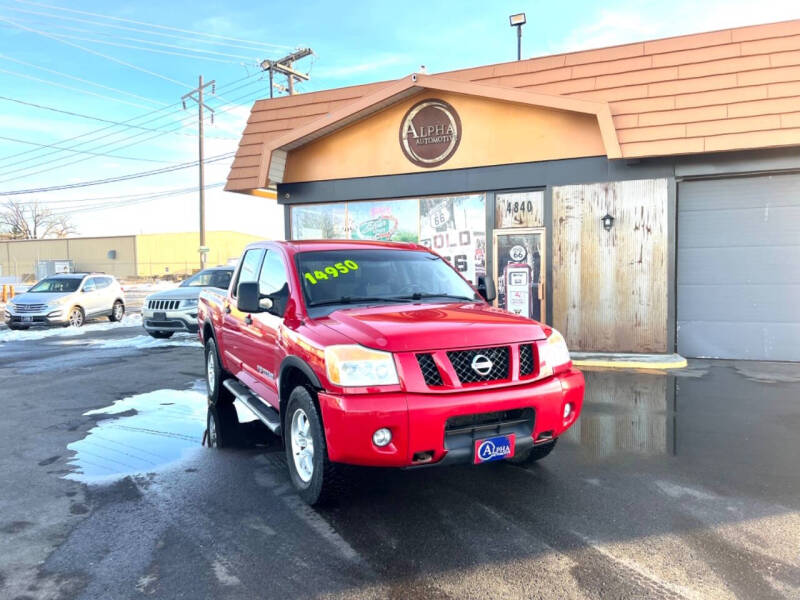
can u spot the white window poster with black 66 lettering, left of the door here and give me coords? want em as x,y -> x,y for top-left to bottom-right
419,194 -> 486,283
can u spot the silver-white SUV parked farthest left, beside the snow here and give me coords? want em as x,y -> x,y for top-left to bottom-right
5,273 -> 125,329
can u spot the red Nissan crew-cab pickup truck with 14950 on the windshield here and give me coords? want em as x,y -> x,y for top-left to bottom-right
197,241 -> 584,504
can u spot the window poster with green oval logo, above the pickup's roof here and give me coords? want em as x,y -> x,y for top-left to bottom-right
347,199 -> 419,242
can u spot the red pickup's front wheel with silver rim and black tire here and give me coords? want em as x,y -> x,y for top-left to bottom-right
284,386 -> 342,506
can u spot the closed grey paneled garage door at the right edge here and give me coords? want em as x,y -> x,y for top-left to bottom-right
677,175 -> 800,361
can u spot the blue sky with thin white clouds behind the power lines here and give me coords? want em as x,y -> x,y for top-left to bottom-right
0,0 -> 800,236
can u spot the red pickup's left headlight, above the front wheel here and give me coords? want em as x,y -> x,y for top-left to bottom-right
325,345 -> 400,387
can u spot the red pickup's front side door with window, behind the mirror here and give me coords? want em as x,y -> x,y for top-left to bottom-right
234,250 -> 289,409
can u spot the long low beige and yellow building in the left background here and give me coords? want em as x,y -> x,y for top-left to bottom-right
0,231 -> 261,280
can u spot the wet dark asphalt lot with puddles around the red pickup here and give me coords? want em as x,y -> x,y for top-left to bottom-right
0,326 -> 800,599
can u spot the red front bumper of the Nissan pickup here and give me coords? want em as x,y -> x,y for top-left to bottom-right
319,369 -> 584,467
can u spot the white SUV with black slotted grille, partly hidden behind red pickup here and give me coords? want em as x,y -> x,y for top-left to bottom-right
142,266 -> 234,338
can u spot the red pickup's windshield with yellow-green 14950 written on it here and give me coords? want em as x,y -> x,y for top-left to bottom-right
295,249 -> 478,308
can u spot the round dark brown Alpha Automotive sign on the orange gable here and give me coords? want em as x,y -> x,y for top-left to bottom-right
400,100 -> 461,168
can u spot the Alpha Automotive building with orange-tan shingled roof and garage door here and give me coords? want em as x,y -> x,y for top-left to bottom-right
226,20 -> 800,361
